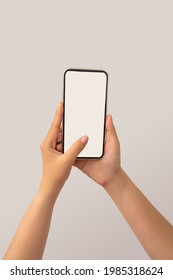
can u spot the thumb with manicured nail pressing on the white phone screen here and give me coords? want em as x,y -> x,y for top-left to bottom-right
64,135 -> 88,163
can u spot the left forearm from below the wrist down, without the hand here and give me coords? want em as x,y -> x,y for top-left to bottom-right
4,184 -> 55,260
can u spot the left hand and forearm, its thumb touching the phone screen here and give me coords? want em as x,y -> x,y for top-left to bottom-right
4,103 -> 88,260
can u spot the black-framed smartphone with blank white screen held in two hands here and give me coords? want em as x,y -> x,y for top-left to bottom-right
62,69 -> 108,159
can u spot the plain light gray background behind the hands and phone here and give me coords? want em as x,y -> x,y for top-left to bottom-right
0,0 -> 173,259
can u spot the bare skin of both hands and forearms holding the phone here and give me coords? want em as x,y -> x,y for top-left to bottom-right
4,103 -> 173,259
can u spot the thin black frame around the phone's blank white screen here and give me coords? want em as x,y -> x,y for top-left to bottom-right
62,68 -> 108,160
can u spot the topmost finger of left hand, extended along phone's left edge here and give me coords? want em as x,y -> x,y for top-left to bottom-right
46,102 -> 63,147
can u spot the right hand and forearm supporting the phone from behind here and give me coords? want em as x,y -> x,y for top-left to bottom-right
75,112 -> 173,259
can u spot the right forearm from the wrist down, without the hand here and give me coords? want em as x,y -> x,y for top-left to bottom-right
106,167 -> 173,259
